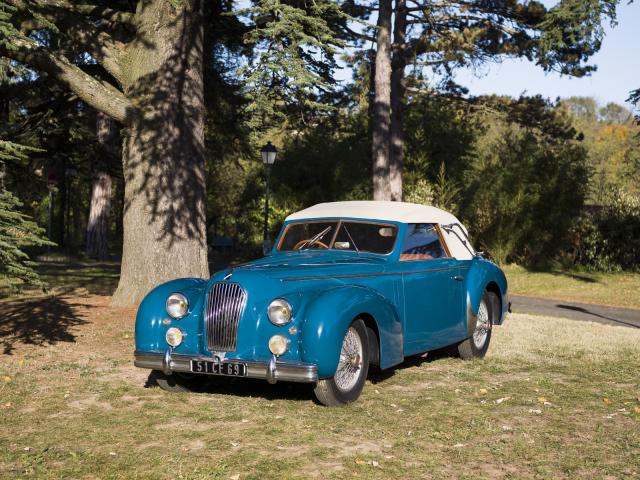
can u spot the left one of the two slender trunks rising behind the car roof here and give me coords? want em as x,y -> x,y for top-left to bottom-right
371,0 -> 392,200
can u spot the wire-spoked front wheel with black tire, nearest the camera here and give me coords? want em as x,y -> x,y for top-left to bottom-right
314,319 -> 369,407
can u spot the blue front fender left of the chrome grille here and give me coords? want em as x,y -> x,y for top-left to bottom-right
135,278 -> 207,353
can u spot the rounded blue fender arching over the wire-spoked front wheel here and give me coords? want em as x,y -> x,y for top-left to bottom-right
300,285 -> 403,378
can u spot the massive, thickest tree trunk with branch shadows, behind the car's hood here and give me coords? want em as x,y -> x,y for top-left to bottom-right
112,0 -> 209,305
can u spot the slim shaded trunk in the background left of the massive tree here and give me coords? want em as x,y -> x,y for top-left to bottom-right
87,112 -> 117,260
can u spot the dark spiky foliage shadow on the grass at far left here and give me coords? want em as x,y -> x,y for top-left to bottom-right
0,296 -> 89,355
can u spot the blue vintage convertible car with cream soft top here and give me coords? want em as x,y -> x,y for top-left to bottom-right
135,201 -> 509,405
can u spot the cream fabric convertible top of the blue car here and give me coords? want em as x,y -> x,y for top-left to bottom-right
286,201 -> 473,260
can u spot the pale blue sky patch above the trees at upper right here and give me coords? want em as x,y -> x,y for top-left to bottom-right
455,0 -> 640,108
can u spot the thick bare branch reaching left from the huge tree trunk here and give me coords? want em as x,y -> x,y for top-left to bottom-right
0,37 -> 131,123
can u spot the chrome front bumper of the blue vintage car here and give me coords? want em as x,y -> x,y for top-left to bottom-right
133,349 -> 318,383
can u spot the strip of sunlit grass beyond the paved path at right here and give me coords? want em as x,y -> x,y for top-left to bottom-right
504,265 -> 640,308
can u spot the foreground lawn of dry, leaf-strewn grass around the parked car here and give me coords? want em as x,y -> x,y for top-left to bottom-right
0,296 -> 640,479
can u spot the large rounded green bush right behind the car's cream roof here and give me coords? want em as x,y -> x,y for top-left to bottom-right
405,95 -> 588,262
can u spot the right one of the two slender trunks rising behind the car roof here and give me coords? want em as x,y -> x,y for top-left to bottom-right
389,0 -> 407,202
